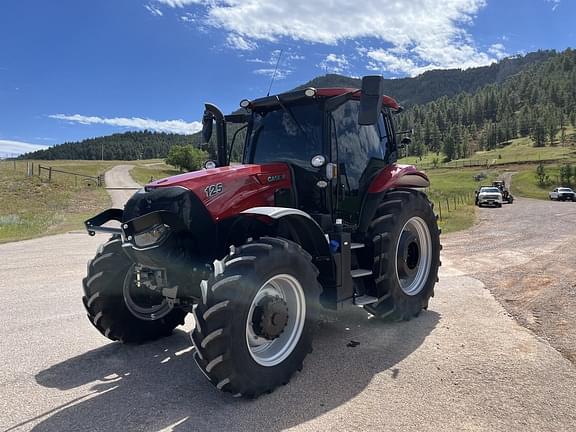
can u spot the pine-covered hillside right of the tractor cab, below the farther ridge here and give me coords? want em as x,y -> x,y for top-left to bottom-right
398,49 -> 576,160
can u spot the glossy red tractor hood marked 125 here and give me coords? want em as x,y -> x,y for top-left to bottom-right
147,163 -> 292,221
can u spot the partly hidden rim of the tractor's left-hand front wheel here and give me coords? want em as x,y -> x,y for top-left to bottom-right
122,265 -> 172,321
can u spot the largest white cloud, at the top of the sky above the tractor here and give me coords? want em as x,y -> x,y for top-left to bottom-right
158,0 -> 504,74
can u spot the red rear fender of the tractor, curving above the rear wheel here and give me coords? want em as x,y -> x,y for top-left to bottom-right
358,164 -> 430,232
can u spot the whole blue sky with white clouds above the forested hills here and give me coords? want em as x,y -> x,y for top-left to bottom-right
0,0 -> 576,155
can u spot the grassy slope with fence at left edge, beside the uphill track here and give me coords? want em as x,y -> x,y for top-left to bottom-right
0,161 -> 114,242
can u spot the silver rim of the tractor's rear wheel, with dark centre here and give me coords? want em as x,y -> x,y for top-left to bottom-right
396,216 -> 432,296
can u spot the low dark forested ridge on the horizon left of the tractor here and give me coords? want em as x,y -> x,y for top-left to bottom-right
21,130 -> 201,160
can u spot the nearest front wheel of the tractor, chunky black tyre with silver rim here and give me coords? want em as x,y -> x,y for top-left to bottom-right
191,237 -> 321,398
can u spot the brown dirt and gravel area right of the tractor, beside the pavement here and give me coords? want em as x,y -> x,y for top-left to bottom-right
443,198 -> 576,363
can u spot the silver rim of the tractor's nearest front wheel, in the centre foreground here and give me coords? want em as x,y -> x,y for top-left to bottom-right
246,274 -> 306,367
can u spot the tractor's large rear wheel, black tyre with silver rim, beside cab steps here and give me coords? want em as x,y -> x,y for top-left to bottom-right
364,189 -> 441,321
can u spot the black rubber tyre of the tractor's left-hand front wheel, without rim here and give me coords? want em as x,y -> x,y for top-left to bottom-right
82,236 -> 186,343
